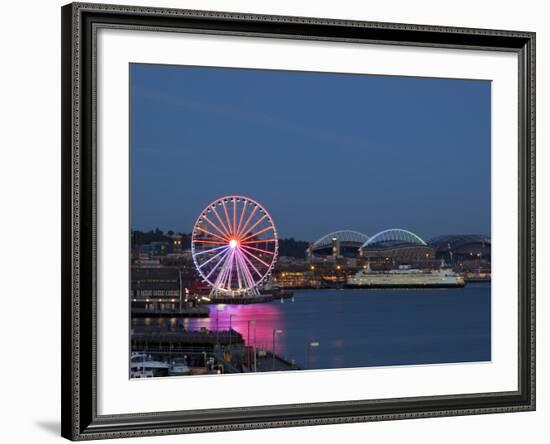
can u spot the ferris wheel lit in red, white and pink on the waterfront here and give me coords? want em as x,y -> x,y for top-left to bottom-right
191,196 -> 279,295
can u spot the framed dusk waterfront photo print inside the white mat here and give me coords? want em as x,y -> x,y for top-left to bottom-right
129,63 -> 491,379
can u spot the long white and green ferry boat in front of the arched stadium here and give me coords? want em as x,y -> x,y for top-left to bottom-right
346,265 -> 465,288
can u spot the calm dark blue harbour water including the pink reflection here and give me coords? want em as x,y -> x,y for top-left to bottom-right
185,283 -> 491,369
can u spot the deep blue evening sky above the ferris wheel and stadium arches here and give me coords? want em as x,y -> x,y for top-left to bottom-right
130,64 -> 491,241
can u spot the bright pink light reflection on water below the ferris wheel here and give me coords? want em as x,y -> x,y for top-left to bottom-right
184,303 -> 285,353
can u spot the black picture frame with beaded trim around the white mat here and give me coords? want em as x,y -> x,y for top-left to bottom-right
61,3 -> 535,440
